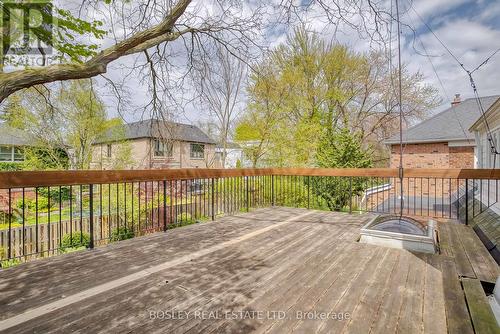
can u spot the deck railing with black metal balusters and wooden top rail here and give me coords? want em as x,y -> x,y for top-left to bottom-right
0,168 -> 500,265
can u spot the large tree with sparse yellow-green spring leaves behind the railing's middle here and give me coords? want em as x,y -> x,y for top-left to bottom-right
235,28 -> 438,166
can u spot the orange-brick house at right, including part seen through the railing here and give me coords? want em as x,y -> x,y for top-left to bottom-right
366,95 -> 500,216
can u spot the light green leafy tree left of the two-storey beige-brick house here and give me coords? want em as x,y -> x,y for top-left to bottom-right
2,80 -> 131,170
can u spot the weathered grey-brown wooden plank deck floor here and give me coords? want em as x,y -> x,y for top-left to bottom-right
0,208 -> 499,333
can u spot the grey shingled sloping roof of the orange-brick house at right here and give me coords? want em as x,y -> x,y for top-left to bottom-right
385,95 -> 500,144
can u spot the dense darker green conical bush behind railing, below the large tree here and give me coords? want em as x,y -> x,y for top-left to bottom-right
311,128 -> 373,210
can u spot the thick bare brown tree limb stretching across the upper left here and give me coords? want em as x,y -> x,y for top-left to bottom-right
0,0 -> 191,103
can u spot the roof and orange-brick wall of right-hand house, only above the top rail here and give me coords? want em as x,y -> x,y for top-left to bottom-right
385,95 -> 500,168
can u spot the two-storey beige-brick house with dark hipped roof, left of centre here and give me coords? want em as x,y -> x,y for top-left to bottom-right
91,119 -> 220,169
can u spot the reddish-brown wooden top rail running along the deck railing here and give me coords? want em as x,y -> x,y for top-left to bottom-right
0,168 -> 500,189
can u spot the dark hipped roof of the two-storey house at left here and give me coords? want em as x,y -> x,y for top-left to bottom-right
94,119 -> 216,144
